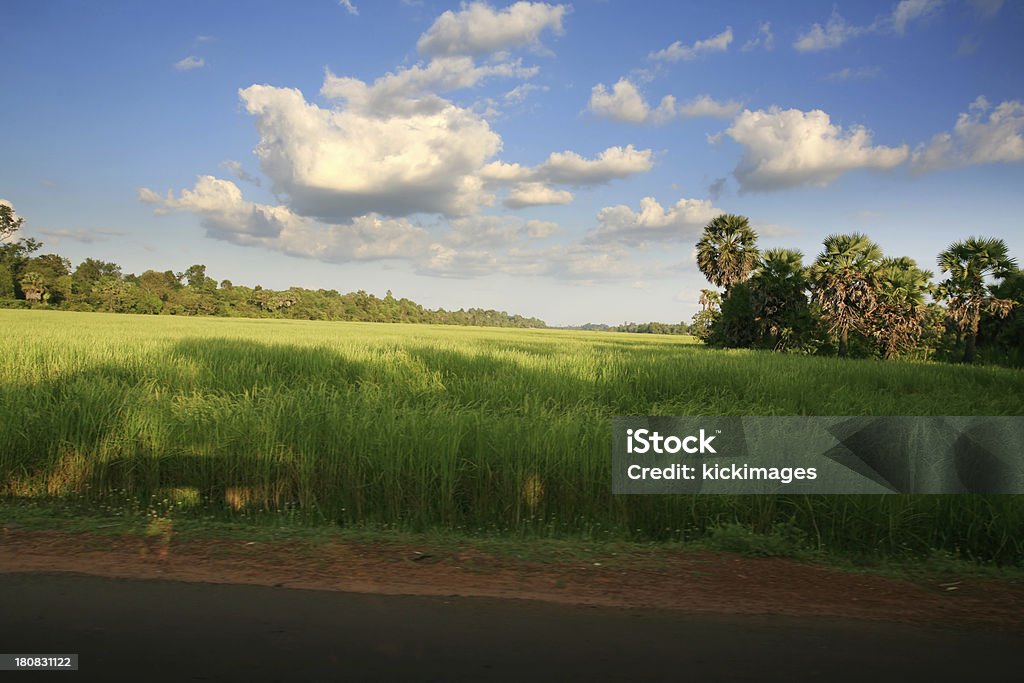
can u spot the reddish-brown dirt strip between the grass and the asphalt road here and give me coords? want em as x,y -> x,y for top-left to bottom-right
0,528 -> 1024,632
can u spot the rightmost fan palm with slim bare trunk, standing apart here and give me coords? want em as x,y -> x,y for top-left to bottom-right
939,238 -> 1017,362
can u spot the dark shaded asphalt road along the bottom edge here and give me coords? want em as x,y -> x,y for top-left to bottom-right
0,573 -> 1024,683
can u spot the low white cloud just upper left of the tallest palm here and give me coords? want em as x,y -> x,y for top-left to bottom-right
587,197 -> 725,246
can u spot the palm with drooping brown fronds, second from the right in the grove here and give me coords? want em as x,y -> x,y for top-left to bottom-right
872,256 -> 932,358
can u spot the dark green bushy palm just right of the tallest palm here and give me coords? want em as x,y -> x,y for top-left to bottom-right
751,249 -> 808,350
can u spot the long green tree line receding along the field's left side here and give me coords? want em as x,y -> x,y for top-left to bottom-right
0,204 -> 547,328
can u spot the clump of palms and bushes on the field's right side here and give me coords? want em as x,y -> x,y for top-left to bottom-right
690,214 -> 1024,366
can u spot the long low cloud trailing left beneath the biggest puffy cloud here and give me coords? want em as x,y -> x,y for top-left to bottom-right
138,175 -> 427,263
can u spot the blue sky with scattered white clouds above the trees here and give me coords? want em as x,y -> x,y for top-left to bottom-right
0,0 -> 1024,325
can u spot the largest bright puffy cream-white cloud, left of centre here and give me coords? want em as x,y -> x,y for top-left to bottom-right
240,75 -> 502,222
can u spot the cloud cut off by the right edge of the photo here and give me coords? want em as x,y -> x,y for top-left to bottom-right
910,97 -> 1024,172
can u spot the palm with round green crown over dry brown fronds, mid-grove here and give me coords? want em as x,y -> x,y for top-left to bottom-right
811,232 -> 882,357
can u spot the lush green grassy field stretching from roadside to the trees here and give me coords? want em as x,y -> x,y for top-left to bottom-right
6,310 -> 1024,564
